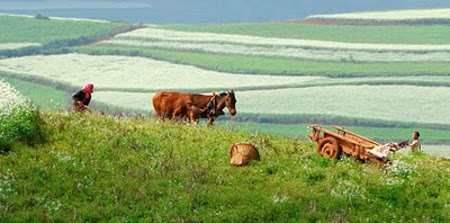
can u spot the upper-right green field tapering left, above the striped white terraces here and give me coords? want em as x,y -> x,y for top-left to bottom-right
156,23 -> 450,44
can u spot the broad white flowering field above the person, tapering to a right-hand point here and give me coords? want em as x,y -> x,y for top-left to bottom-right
0,54 -> 323,92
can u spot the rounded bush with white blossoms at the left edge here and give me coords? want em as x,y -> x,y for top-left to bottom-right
0,81 -> 40,152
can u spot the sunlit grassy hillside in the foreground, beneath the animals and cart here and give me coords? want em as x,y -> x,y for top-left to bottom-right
0,113 -> 450,222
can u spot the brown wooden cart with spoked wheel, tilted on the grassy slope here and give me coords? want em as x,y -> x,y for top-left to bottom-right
308,125 -> 386,163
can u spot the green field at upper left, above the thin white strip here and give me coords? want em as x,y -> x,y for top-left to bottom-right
0,15 -> 130,44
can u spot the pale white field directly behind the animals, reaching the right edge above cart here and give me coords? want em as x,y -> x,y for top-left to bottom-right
91,85 -> 450,124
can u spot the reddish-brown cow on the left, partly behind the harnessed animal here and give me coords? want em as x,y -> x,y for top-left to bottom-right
153,91 -> 206,122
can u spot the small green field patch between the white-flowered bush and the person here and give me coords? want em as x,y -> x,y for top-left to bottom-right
0,75 -> 71,110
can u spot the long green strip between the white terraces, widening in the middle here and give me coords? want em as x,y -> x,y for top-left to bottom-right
74,45 -> 450,77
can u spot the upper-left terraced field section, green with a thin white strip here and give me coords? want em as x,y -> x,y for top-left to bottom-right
0,14 -> 134,58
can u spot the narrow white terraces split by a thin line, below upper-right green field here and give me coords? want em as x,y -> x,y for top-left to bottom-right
91,28 -> 450,62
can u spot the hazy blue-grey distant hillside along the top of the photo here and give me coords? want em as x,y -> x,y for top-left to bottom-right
0,0 -> 450,24
